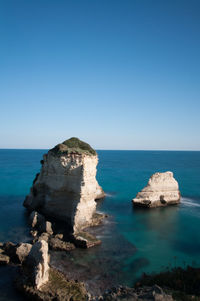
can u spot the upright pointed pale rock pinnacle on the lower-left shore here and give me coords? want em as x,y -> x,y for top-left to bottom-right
23,240 -> 49,289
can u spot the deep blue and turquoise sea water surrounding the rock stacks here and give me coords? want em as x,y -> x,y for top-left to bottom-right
0,150 -> 200,300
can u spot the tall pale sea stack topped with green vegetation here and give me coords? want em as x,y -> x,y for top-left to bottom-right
24,138 -> 104,233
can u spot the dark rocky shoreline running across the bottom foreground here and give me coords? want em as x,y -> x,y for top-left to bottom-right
0,237 -> 200,301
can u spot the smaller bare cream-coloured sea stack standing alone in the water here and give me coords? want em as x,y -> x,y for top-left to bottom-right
133,171 -> 181,208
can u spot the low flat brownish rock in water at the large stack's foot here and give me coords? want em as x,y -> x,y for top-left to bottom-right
73,231 -> 101,249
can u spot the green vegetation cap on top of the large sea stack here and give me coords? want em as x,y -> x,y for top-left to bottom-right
50,137 -> 96,155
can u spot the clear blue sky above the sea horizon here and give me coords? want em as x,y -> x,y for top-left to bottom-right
0,0 -> 200,150
